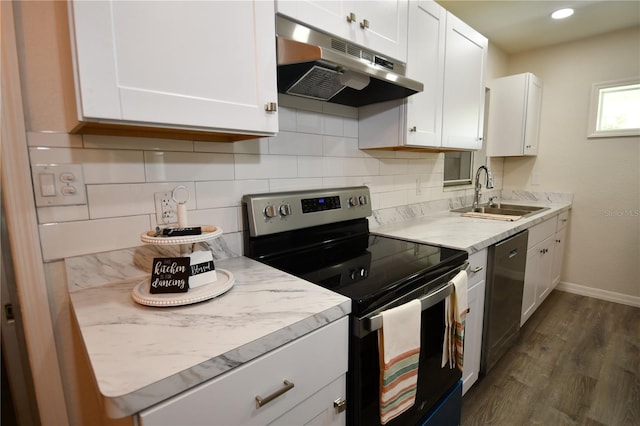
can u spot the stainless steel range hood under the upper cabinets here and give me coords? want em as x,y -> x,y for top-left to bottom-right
276,16 -> 423,107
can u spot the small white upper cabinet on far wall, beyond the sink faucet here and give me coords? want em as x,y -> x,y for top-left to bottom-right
487,73 -> 542,157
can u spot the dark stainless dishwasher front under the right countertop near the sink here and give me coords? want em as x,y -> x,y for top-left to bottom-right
480,229 -> 529,375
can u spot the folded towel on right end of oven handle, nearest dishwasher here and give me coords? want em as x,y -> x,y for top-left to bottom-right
442,271 -> 469,371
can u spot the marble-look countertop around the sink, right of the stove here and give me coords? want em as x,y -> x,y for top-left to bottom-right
372,200 -> 572,254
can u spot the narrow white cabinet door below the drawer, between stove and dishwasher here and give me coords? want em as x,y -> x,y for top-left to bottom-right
462,280 -> 485,395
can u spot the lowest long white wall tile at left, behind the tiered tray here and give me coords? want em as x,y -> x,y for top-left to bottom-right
39,216 -> 150,261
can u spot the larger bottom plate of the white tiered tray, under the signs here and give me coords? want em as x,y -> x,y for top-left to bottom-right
131,269 -> 236,307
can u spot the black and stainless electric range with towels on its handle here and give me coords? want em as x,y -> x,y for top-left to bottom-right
242,186 -> 468,426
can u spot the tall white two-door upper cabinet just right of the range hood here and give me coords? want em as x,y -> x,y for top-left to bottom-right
359,0 -> 487,150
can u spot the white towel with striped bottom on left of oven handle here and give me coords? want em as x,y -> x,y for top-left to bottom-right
378,299 -> 422,424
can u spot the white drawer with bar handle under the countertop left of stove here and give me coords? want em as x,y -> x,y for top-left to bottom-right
139,317 -> 349,426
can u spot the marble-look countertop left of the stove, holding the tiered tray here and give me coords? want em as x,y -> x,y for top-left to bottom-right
65,251 -> 351,418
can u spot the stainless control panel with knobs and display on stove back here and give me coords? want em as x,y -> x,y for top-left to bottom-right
242,186 -> 371,237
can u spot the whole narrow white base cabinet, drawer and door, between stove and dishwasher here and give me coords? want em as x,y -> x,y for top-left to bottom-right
462,249 -> 487,395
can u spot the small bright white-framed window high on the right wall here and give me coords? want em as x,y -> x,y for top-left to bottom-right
588,79 -> 640,138
